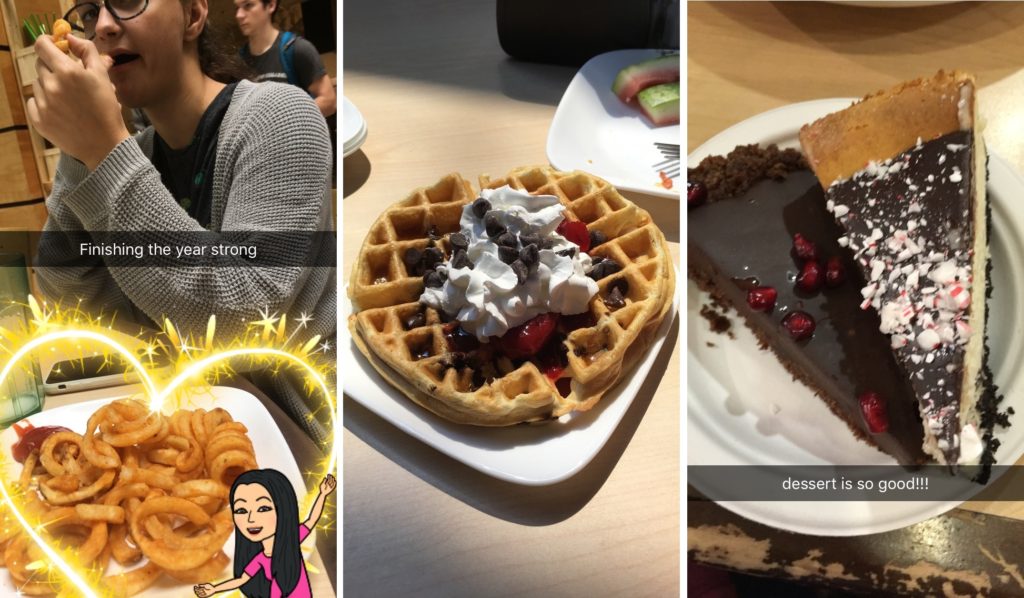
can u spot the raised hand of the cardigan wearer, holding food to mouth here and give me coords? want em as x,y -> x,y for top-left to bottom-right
28,35 -> 130,170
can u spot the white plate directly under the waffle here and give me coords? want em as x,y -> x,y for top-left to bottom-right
338,287 -> 679,485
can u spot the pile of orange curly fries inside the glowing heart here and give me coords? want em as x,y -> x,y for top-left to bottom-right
0,399 -> 257,596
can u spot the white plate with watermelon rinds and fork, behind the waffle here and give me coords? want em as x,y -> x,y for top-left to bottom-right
548,50 -> 682,200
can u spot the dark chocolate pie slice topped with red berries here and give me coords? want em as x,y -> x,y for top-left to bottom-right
687,145 -> 928,465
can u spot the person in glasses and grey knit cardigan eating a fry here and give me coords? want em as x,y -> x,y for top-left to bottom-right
26,0 -> 338,445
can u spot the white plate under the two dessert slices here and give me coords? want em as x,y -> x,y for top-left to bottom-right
686,99 -> 1024,536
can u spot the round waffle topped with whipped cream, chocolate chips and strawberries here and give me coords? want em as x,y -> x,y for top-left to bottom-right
349,167 -> 675,426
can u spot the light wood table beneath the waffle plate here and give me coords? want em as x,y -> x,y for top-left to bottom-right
341,0 -> 680,597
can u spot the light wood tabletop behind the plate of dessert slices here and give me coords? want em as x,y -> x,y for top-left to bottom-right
687,2 -> 1024,591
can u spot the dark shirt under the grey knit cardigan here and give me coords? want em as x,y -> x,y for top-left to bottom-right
153,83 -> 237,228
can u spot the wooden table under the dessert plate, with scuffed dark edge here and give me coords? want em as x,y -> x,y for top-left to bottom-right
687,2 -> 1024,595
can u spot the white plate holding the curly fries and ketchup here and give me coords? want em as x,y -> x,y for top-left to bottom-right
0,386 -> 307,598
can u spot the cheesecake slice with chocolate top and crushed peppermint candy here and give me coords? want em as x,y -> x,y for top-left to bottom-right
800,72 -> 998,468
